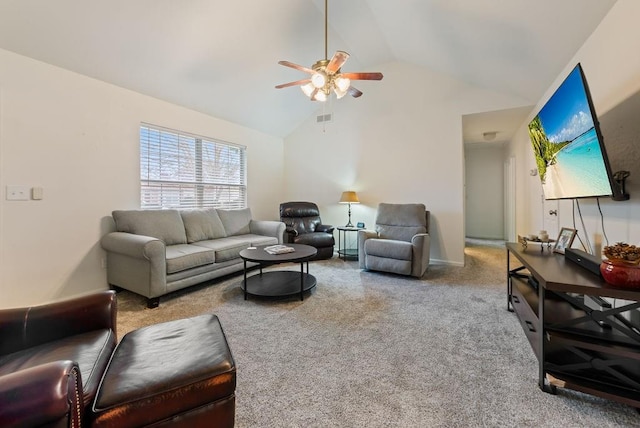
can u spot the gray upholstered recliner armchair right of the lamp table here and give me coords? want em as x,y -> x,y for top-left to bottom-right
358,203 -> 431,278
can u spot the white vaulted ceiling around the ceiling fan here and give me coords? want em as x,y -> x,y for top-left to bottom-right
0,0 -> 615,137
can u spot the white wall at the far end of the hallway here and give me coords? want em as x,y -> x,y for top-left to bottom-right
464,143 -> 505,239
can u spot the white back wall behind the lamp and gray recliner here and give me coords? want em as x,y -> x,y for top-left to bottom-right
284,63 -> 527,265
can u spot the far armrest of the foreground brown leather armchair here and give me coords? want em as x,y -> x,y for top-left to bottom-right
0,290 -> 117,355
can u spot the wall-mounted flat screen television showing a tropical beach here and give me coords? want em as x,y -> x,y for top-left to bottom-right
529,64 -> 615,199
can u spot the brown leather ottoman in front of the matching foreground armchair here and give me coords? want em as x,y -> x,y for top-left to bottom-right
93,315 -> 236,427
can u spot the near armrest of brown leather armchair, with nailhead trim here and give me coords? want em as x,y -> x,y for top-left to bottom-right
0,361 -> 84,427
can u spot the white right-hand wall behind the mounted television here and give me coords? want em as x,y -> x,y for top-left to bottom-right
509,0 -> 640,255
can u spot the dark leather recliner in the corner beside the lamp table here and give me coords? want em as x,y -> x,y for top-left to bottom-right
280,202 -> 335,260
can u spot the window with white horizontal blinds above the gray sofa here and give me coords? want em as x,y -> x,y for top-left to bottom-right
140,124 -> 247,209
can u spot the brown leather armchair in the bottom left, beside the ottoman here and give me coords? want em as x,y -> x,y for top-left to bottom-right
0,291 -> 117,427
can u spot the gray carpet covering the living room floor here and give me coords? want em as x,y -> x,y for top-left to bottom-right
118,241 -> 640,427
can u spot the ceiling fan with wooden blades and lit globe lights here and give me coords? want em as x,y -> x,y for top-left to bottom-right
276,0 -> 383,101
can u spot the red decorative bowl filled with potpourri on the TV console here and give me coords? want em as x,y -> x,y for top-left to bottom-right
600,242 -> 640,288
